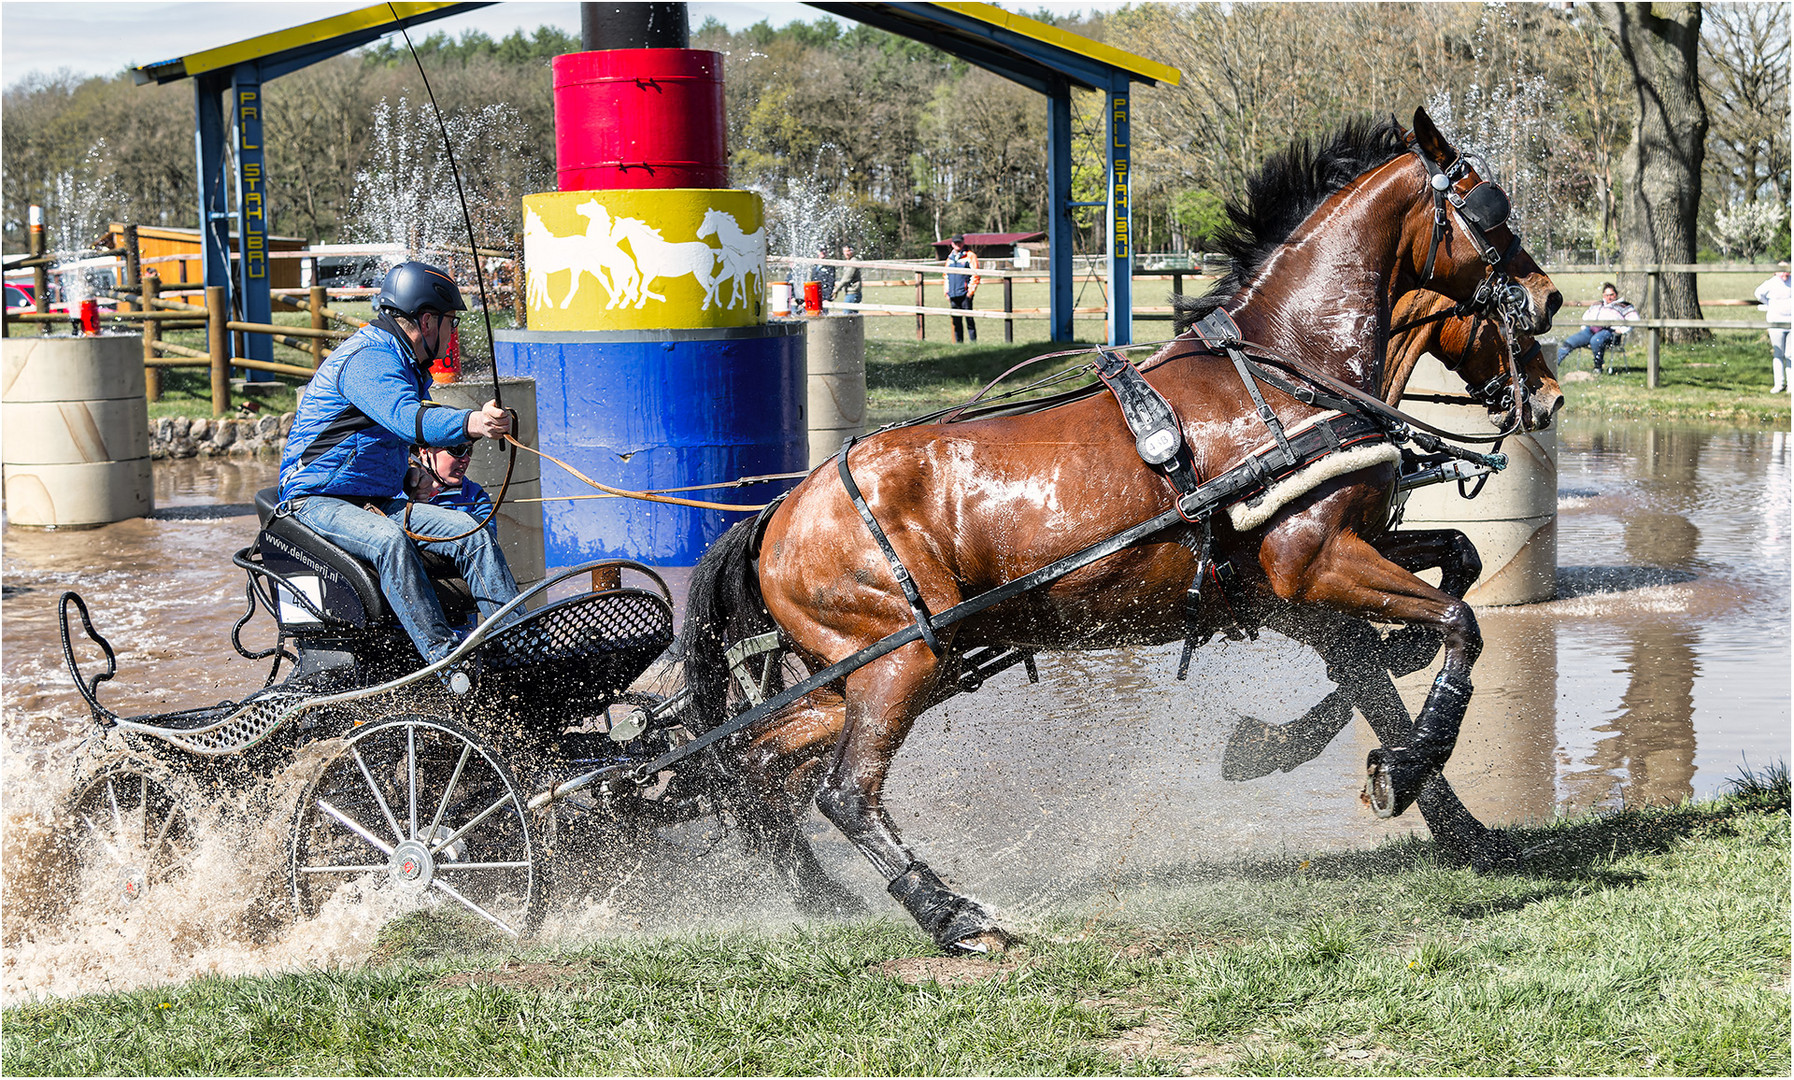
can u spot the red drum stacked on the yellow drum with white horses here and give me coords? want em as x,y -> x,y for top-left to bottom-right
554,48 -> 728,192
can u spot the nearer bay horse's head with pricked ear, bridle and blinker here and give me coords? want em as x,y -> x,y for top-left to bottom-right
1405,109 -> 1563,334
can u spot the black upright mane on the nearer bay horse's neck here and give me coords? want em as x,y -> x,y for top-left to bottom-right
1171,117 -> 1408,334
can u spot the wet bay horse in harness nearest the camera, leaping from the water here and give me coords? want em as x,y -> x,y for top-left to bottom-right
682,109 -> 1563,951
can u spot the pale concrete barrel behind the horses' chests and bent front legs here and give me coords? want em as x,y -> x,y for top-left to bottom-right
1401,357 -> 1557,606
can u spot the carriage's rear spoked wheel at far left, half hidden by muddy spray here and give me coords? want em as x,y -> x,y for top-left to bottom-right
66,753 -> 197,906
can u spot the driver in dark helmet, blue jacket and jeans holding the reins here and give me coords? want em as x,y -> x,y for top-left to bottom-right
280,262 -> 517,664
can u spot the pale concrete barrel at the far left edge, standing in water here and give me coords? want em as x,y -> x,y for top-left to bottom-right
0,334 -> 156,529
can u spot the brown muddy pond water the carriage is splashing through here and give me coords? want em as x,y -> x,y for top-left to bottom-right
0,422 -> 1794,1001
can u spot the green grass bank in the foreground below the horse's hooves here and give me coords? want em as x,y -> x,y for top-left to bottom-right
0,768 -> 1790,1075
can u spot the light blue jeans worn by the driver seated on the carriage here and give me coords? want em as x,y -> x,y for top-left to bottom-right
292,495 -> 517,664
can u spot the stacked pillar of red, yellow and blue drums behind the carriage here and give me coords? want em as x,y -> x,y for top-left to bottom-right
495,37 -> 809,567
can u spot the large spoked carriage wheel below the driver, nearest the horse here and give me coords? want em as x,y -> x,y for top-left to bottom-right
289,716 -> 545,936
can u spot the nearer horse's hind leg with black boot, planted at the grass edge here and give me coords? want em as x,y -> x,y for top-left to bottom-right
816,642 -> 1010,953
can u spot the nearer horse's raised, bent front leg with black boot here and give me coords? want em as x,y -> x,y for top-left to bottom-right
1259,527 -> 1482,816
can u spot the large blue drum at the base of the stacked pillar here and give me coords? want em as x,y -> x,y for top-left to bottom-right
497,323 -> 809,567
